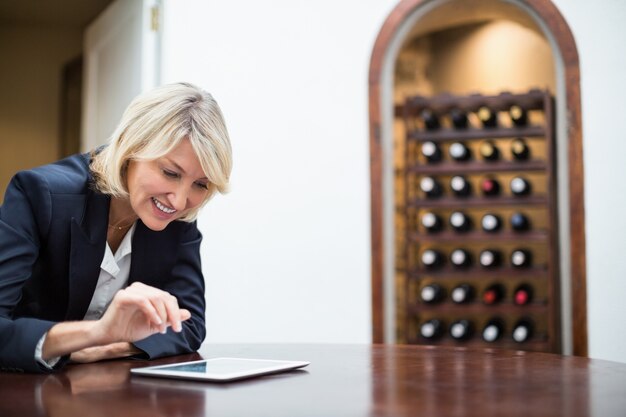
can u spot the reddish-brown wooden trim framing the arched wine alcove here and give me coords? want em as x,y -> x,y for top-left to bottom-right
369,0 -> 587,356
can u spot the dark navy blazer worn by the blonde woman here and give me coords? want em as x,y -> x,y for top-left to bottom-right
0,154 -> 205,372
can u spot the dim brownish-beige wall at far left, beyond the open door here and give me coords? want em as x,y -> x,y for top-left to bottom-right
0,23 -> 82,201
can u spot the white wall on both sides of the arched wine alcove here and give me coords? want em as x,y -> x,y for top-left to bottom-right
163,0 -> 626,361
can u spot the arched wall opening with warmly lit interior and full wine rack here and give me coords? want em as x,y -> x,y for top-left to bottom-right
370,0 -> 586,353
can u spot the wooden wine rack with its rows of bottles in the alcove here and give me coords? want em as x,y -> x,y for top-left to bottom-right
399,90 -> 561,352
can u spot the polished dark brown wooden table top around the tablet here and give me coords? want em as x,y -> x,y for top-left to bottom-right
0,344 -> 626,417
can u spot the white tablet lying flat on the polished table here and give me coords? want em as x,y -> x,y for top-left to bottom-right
130,358 -> 310,382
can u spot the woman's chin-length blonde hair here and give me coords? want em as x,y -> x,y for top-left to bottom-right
90,83 -> 232,222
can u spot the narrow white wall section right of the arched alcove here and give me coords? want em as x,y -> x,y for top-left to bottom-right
554,0 -> 626,362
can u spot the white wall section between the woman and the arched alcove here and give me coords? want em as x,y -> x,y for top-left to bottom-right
163,0 -> 394,342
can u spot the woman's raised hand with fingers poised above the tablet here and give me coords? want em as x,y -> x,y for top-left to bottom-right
96,282 -> 191,344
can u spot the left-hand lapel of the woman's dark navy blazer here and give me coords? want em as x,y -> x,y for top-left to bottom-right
65,191 -> 110,320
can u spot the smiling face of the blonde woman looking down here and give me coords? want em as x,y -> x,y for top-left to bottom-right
126,139 -> 209,231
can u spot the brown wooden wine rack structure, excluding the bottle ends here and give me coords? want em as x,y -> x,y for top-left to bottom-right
396,90 -> 561,352
